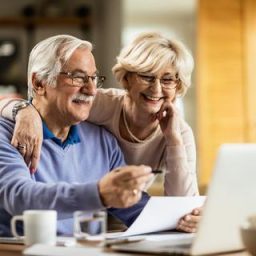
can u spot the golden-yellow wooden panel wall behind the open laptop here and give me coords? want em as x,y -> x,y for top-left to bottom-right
197,0 -> 256,189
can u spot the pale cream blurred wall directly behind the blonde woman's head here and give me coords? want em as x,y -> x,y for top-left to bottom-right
122,0 -> 197,136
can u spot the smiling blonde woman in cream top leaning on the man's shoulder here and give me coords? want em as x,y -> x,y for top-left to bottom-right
2,33 -> 200,232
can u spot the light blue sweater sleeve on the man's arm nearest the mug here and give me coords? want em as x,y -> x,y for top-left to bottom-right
0,136 -> 103,218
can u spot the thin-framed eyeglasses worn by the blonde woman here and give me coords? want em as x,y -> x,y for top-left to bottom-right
136,73 -> 180,89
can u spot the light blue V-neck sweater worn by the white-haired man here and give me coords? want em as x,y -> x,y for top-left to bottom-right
0,118 -> 148,236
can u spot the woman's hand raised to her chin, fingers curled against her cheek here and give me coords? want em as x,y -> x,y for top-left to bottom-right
157,101 -> 182,146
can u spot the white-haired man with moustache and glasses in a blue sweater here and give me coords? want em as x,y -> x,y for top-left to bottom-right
0,35 -> 153,235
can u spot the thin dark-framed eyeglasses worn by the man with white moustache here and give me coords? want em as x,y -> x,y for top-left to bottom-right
59,71 -> 106,87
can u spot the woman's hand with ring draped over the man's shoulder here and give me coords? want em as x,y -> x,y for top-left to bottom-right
11,106 -> 43,173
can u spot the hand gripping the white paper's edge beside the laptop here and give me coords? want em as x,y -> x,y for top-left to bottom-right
176,207 -> 202,233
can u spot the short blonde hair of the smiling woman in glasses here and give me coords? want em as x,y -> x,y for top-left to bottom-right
112,32 -> 194,96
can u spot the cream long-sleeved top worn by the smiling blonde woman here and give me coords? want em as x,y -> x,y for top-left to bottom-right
88,88 -> 198,196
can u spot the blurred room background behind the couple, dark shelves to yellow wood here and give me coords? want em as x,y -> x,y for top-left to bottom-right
0,0 -> 256,194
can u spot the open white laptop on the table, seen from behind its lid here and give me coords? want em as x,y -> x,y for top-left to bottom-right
112,144 -> 256,255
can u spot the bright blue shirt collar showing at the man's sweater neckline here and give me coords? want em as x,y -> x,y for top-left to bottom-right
43,122 -> 81,149
